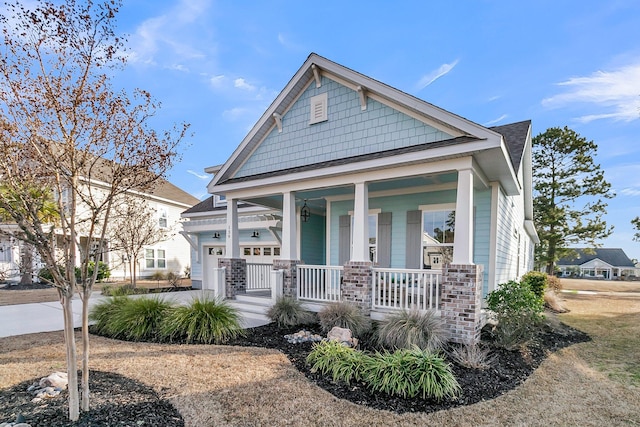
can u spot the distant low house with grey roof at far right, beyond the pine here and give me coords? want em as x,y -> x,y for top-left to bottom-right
556,248 -> 637,280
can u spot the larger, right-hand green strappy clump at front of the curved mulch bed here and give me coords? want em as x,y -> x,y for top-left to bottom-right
363,347 -> 461,400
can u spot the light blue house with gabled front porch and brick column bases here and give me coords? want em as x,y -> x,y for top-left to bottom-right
183,54 -> 538,342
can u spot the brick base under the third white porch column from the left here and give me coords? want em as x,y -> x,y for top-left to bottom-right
340,261 -> 373,315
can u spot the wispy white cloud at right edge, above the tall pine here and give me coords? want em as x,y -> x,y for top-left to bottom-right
542,63 -> 640,123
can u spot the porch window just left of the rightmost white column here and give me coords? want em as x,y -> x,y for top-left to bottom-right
422,208 -> 456,270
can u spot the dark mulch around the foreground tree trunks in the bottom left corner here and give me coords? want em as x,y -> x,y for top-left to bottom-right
0,371 -> 184,427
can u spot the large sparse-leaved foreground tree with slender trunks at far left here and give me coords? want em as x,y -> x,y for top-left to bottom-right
0,0 -> 187,421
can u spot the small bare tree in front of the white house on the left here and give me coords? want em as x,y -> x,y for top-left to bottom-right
110,195 -> 171,287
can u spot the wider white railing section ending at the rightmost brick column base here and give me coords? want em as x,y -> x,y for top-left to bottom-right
372,268 -> 442,310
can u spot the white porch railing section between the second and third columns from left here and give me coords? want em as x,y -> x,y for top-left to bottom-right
298,264 -> 343,301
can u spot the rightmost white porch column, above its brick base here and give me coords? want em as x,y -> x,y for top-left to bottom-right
453,169 -> 473,264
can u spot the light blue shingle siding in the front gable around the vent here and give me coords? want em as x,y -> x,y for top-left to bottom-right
235,77 -> 451,177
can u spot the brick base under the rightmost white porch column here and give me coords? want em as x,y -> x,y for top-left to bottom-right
441,264 -> 484,344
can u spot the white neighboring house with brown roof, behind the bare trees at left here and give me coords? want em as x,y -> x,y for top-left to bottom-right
0,171 -> 198,281
